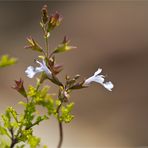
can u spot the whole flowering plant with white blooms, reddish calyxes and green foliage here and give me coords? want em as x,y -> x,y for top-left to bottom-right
0,5 -> 113,148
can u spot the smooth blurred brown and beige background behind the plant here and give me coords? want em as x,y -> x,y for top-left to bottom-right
0,1 -> 148,148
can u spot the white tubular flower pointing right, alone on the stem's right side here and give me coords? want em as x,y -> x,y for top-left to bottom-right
83,68 -> 114,91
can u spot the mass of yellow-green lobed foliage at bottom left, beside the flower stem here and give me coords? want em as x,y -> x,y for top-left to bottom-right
0,83 -> 54,148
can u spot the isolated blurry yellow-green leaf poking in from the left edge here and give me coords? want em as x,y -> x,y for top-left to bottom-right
0,55 -> 17,67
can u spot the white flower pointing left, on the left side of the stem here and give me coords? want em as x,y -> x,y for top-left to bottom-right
25,60 -> 52,78
